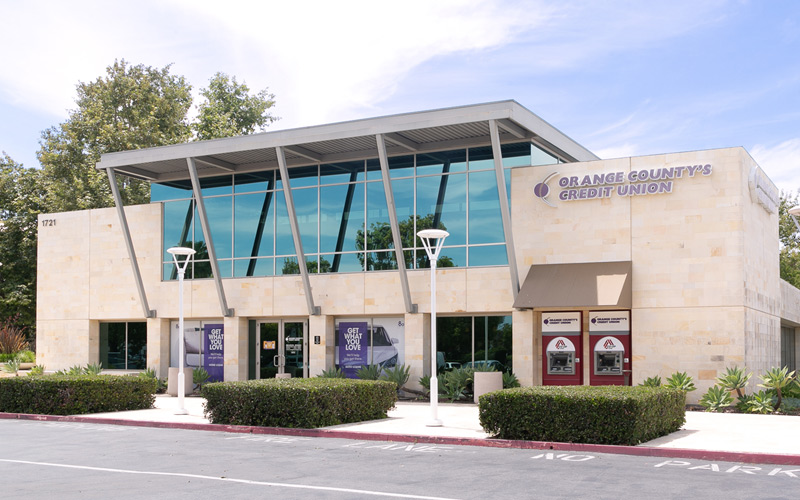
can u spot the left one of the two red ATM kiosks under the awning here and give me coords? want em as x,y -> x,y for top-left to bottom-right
542,312 -> 583,385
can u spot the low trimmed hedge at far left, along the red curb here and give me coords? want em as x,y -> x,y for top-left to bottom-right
0,375 -> 156,415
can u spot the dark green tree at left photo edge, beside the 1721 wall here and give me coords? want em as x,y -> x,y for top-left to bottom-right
0,153 -> 46,331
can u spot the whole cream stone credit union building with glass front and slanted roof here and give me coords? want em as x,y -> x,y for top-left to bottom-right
37,101 -> 800,397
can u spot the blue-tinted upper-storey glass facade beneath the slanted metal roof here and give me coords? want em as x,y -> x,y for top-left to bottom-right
151,142 -> 557,280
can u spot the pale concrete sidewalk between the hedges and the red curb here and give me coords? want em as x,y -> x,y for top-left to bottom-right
59,395 -> 800,465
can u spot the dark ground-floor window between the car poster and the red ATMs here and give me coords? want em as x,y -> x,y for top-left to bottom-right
436,316 -> 512,371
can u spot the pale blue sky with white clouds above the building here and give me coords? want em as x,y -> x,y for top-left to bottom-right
0,0 -> 800,192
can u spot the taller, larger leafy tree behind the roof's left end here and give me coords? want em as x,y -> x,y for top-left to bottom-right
38,59 -> 192,212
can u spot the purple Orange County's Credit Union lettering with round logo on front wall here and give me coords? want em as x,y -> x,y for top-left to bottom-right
533,164 -> 713,207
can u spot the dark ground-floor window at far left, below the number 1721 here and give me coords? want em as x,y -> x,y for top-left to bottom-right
100,321 -> 147,370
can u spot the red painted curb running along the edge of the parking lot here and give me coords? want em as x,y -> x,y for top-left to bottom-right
0,413 -> 800,466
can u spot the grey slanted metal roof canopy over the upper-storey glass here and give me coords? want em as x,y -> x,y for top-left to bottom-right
96,100 -> 599,182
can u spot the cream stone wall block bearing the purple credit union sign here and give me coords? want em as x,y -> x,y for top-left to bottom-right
511,148 -> 781,400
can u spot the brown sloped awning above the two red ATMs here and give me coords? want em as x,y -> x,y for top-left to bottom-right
514,261 -> 632,309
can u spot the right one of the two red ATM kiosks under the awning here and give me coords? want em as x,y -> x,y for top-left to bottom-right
589,311 -> 631,385
